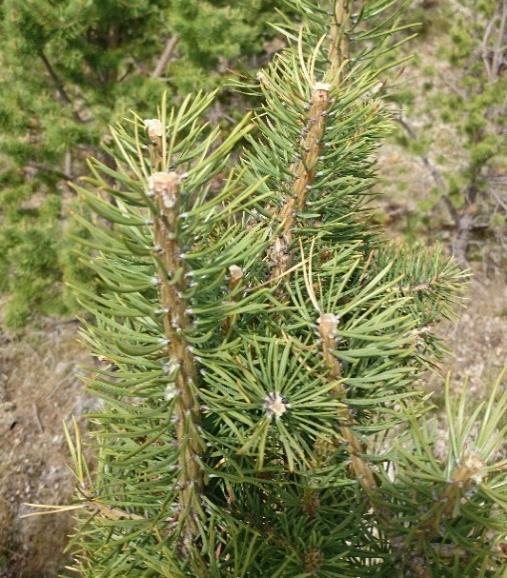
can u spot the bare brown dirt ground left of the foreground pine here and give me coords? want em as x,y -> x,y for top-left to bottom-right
0,323 -> 92,578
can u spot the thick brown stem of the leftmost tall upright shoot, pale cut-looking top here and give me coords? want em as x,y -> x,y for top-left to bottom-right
149,172 -> 205,549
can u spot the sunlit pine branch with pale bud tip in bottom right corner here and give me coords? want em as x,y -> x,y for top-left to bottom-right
384,369 -> 507,578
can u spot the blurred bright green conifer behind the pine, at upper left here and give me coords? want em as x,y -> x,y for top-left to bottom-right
0,0 -> 286,327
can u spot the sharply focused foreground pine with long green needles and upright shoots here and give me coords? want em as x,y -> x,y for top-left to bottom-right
53,0 -> 507,578
